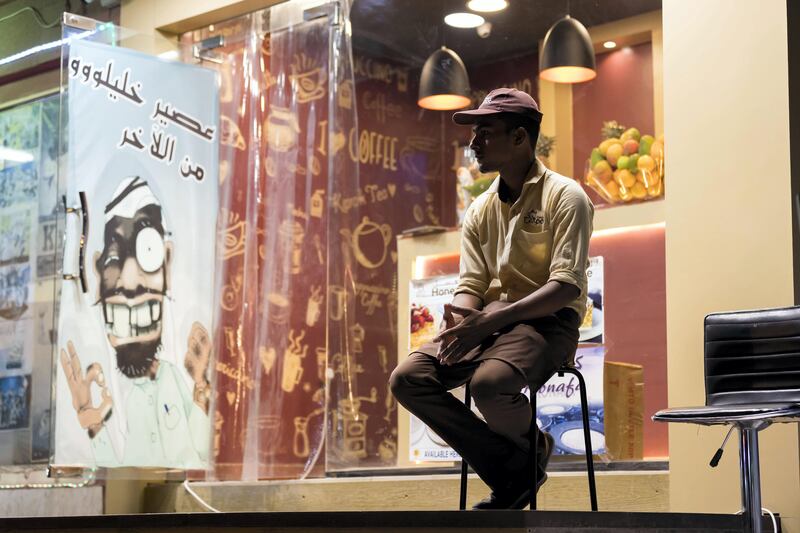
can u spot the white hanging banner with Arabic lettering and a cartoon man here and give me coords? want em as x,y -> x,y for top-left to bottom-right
53,41 -> 219,469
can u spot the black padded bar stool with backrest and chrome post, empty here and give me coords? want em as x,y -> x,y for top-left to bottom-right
653,306 -> 800,533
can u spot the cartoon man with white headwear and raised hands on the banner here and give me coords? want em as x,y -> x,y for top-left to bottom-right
61,176 -> 212,467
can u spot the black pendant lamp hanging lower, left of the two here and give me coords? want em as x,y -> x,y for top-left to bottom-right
417,46 -> 472,111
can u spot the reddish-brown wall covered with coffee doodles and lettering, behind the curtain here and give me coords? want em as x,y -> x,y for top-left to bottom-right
185,21 -> 552,479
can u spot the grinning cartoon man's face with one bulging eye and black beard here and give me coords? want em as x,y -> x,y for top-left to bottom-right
95,204 -> 172,377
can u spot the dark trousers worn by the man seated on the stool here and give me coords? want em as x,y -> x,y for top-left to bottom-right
390,310 -> 580,489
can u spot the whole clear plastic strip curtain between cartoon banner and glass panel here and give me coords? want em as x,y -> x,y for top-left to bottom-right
203,1 -> 351,480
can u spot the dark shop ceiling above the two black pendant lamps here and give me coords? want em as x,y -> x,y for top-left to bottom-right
350,0 -> 662,66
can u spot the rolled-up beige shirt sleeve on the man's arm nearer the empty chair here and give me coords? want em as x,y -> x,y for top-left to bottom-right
548,187 -> 594,295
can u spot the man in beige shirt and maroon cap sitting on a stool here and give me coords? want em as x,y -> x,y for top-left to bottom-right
390,89 -> 594,509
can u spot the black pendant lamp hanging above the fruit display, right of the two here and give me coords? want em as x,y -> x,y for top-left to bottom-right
539,15 -> 597,83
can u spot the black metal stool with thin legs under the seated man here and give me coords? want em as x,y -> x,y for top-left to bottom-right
458,365 -> 597,511
